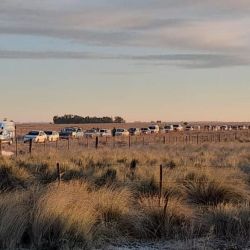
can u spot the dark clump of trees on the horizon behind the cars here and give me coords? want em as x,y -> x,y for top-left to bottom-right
53,115 -> 125,124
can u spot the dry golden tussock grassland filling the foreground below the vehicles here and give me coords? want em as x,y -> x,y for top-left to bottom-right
0,142 -> 250,249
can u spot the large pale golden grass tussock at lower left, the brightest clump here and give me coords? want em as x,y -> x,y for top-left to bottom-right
32,182 -> 97,245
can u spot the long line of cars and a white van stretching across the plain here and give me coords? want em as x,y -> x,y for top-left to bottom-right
0,121 -> 250,144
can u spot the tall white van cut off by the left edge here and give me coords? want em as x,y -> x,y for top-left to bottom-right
0,121 -> 16,144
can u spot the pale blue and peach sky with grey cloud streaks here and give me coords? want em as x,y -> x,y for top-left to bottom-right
0,0 -> 250,122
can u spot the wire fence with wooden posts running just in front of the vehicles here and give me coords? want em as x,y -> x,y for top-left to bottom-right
0,130 -> 250,156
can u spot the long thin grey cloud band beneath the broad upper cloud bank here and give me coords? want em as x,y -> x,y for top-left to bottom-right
0,50 -> 250,69
